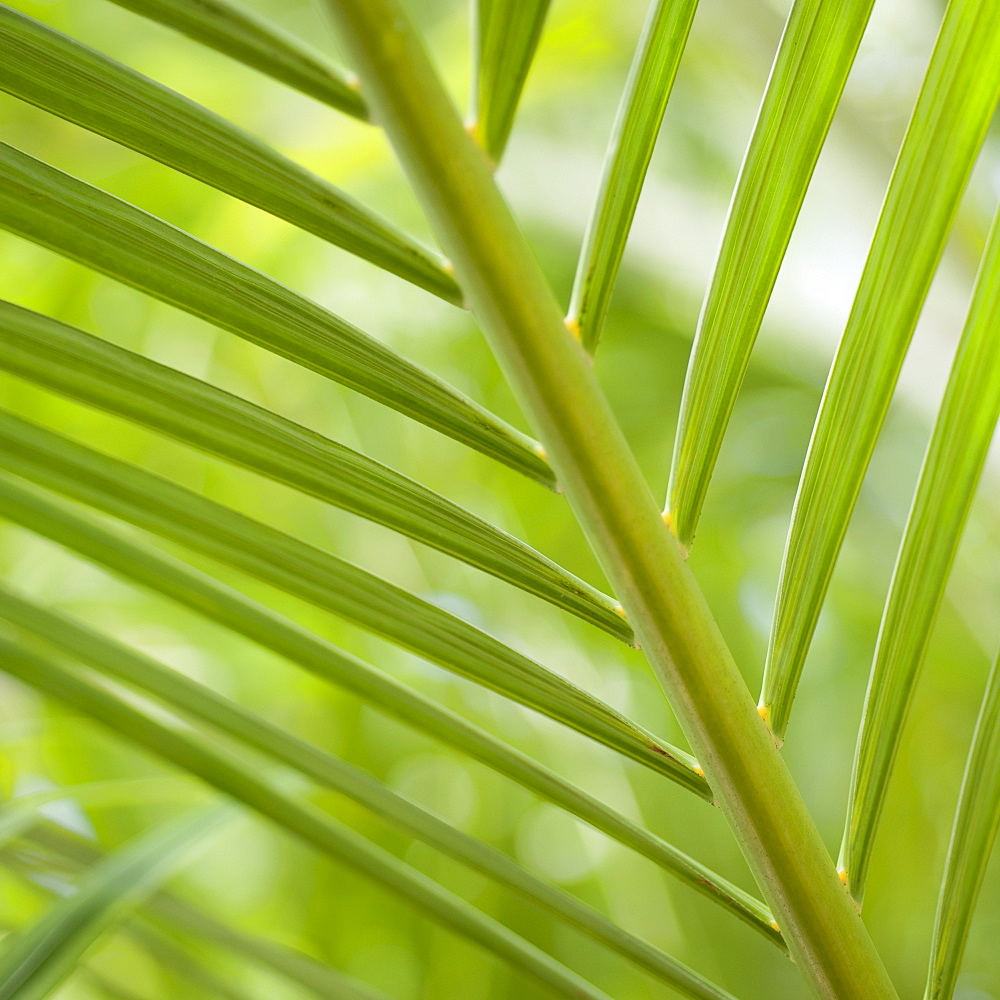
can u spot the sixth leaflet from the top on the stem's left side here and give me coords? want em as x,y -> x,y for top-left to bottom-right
0,477 -> 728,896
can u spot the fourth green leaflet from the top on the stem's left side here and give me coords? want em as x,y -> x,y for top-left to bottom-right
0,301 -> 633,642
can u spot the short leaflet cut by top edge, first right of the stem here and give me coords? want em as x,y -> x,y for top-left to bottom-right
469,0 -> 550,163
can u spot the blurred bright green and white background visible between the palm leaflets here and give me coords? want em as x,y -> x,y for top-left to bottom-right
0,0 -> 1000,1000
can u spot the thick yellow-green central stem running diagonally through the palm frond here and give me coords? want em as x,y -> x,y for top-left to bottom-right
327,0 -> 896,1000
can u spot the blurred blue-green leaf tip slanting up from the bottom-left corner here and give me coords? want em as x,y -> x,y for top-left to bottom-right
0,800 -> 232,1000
